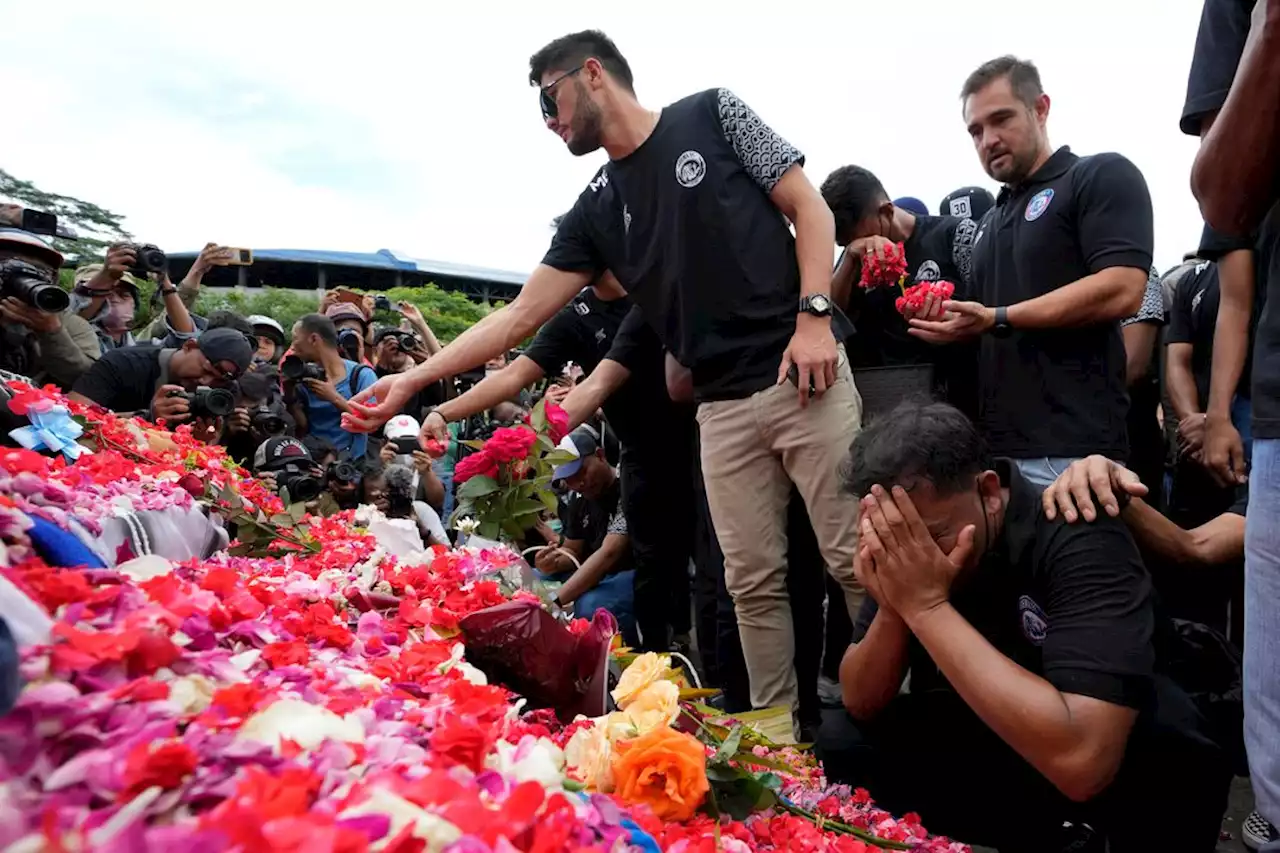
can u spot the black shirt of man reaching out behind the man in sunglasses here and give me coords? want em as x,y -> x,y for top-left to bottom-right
525,288 -> 689,461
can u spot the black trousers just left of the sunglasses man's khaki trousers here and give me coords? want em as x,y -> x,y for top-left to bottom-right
618,438 -> 698,652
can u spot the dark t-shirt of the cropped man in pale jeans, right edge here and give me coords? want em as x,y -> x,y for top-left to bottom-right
1179,0 -> 1280,438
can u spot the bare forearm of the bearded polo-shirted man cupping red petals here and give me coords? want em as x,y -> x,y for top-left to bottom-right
991,266 -> 1149,329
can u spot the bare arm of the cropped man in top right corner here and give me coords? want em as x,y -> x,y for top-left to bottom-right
1192,14 -> 1280,234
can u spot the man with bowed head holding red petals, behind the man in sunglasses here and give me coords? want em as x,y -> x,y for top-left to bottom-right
822,165 -> 978,414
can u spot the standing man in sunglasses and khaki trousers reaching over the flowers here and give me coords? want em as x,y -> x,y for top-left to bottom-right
348,31 -> 861,707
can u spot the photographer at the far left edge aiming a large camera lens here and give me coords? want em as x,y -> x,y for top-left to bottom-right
0,228 -> 99,388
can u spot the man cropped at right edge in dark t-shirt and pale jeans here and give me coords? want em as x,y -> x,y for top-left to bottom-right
1180,0 -> 1280,849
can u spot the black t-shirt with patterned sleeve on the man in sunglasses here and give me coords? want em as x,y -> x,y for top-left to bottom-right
543,88 -> 804,401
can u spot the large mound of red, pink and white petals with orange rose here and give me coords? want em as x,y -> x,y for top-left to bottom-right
0,381 -> 968,853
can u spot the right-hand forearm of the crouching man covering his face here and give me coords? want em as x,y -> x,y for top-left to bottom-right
908,603 -> 1119,800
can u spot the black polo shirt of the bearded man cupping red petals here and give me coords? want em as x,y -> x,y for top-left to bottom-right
973,147 -> 1153,459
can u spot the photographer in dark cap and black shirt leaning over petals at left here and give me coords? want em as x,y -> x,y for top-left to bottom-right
72,329 -> 253,441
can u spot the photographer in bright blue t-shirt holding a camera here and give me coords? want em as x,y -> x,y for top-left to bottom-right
284,314 -> 378,460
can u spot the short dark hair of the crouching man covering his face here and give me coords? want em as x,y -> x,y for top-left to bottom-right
841,402 -> 992,497
